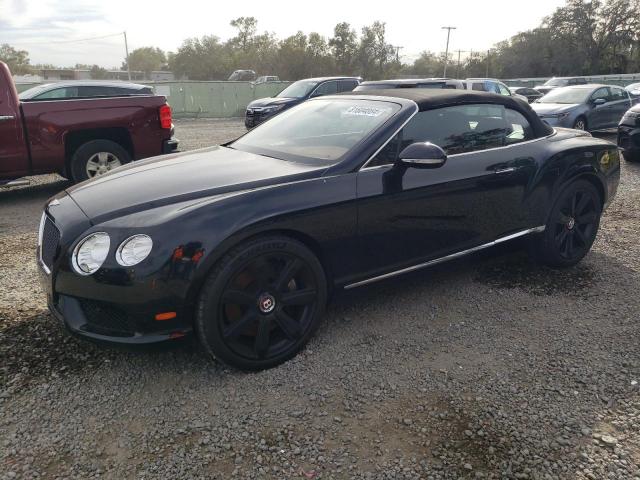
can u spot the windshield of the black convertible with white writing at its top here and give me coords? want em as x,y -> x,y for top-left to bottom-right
229,99 -> 400,166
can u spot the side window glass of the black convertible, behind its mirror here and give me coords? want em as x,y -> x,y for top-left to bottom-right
367,104 -> 534,167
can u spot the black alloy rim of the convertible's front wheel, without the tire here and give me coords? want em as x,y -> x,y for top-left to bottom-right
217,253 -> 318,360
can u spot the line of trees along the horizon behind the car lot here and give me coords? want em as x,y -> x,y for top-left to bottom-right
0,0 -> 640,80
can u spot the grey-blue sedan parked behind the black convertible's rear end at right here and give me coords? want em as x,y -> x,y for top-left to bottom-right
531,84 -> 631,131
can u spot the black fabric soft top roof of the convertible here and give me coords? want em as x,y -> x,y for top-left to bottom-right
339,88 -> 553,137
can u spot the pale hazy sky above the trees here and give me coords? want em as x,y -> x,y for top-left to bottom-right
0,0 -> 564,67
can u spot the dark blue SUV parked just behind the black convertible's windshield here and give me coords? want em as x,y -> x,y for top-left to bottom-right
244,77 -> 360,128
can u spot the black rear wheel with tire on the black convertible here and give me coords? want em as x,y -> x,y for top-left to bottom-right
532,180 -> 602,268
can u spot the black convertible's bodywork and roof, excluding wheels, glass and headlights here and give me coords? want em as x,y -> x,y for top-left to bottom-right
38,89 -> 620,343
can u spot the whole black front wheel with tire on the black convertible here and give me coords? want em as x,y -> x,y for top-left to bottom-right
196,236 -> 327,370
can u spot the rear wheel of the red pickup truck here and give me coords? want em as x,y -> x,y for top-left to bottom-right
71,140 -> 131,182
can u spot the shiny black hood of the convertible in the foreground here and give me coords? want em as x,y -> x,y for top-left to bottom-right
67,146 -> 326,224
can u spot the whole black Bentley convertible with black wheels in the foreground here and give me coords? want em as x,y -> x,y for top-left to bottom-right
38,89 -> 620,370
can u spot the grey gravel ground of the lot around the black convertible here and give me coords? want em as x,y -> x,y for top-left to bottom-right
0,120 -> 640,480
